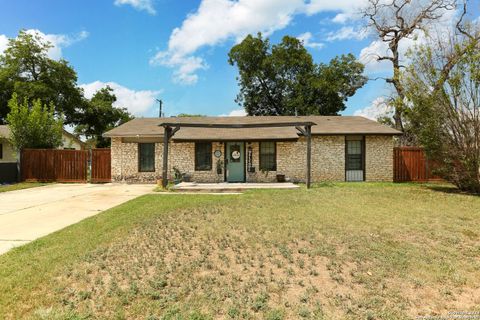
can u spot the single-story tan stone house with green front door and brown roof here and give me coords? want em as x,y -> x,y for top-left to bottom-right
104,116 -> 401,182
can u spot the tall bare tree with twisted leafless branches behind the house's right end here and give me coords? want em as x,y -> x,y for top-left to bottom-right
363,0 -> 457,131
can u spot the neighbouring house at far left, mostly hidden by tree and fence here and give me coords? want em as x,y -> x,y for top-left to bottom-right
0,125 -> 86,183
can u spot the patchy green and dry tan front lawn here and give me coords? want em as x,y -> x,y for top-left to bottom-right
0,183 -> 480,319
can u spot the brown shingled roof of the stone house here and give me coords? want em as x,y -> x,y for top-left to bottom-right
104,116 -> 401,141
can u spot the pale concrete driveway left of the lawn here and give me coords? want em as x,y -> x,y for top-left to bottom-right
0,183 -> 154,254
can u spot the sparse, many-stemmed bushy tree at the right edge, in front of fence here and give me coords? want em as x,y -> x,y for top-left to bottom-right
402,6 -> 480,193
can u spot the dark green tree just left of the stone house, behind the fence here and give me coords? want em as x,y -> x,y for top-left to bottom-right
75,86 -> 133,148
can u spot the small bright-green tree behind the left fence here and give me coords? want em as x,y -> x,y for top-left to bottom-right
6,93 -> 63,150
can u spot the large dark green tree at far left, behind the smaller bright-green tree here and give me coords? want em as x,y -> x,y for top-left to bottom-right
0,30 -> 83,124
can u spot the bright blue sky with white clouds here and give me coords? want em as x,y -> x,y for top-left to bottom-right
0,0 -> 480,118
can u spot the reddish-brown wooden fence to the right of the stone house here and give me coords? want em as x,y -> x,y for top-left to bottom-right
393,147 -> 441,182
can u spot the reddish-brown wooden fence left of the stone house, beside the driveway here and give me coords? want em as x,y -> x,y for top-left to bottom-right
20,149 -> 110,183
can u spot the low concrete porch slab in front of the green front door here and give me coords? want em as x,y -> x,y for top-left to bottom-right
173,182 -> 299,192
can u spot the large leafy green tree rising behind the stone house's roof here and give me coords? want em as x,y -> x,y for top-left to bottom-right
228,33 -> 367,115
